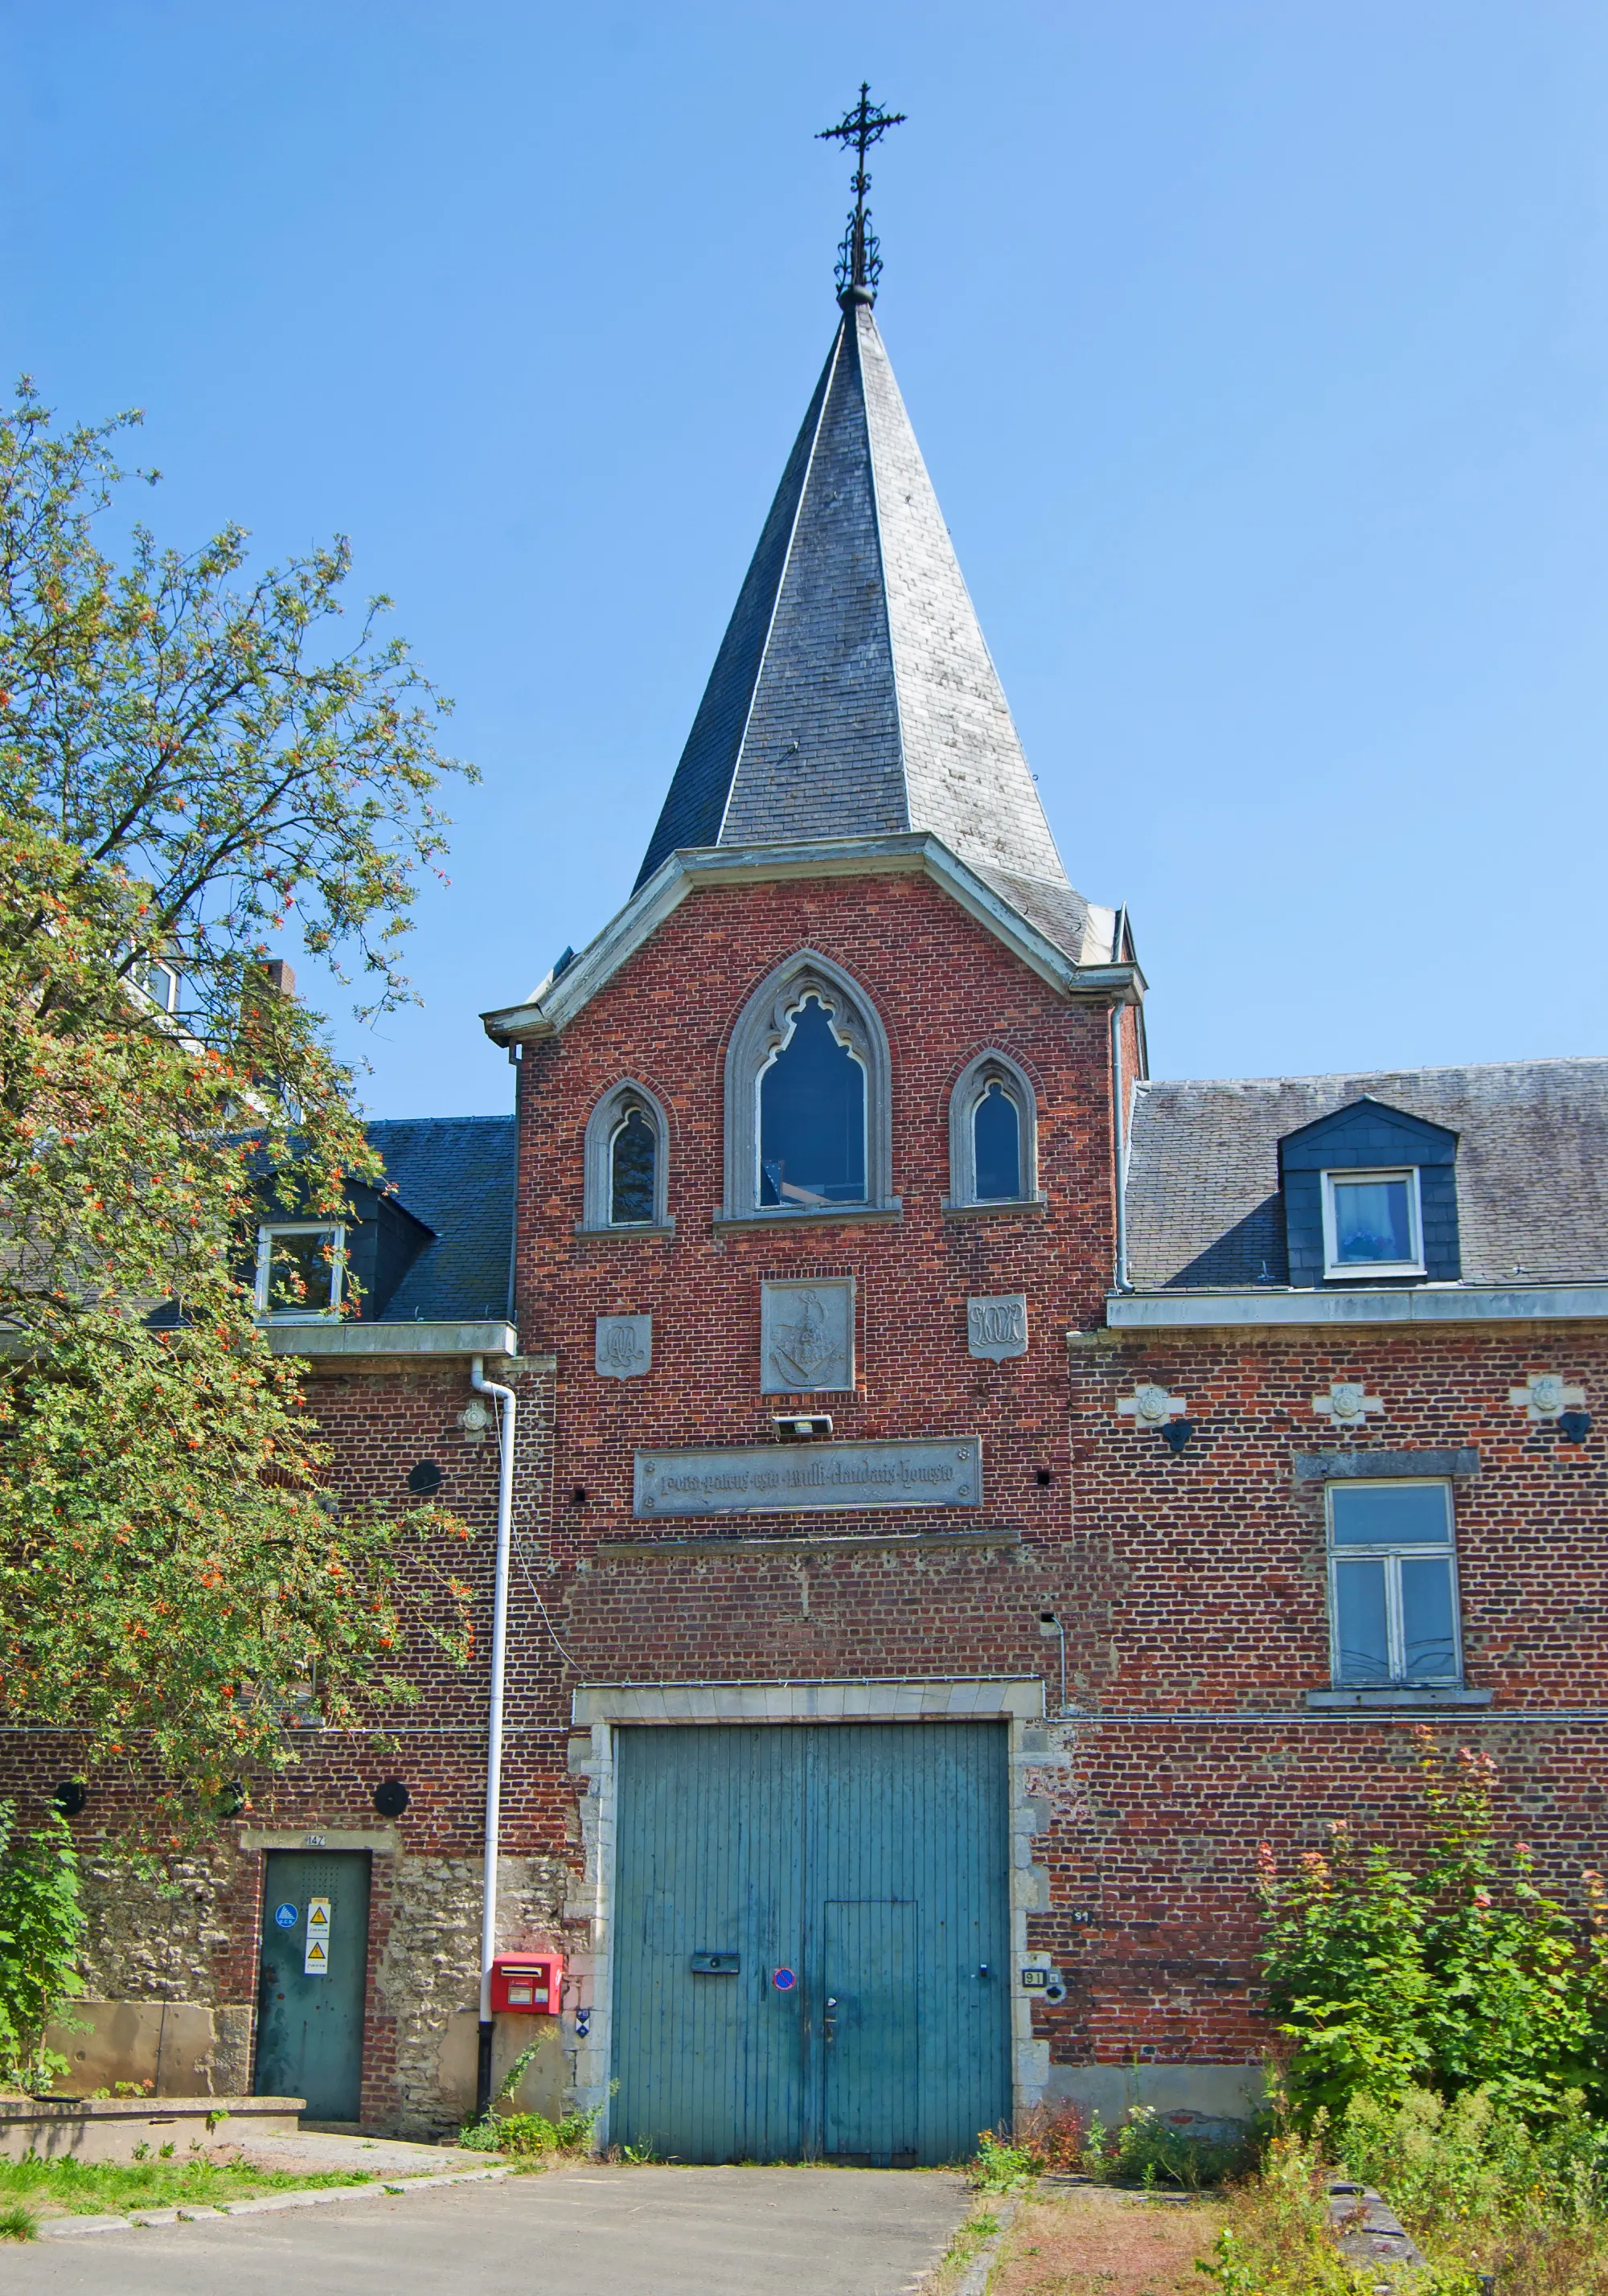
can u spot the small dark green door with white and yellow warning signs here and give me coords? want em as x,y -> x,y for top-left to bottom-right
257,1851 -> 367,2122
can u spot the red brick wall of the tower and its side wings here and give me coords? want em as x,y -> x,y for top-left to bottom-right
6,877 -> 1608,2117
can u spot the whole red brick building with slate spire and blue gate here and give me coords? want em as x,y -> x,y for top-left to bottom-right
18,264 -> 1608,2160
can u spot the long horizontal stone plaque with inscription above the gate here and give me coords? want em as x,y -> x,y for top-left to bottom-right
636,1435 -> 983,1518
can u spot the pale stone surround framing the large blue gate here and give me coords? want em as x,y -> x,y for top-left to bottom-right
565,1674 -> 1050,2145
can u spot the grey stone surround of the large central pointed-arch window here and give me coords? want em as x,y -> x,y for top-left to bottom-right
716,949 -> 900,1226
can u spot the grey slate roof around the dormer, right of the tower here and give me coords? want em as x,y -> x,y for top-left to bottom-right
1128,1059 -> 1608,1290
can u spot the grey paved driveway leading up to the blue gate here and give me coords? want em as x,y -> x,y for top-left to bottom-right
0,2165 -> 967,2296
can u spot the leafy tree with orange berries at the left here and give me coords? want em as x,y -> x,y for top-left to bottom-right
0,388 -> 480,1811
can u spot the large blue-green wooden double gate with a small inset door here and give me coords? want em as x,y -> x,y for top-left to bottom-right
609,1722 -> 1011,2165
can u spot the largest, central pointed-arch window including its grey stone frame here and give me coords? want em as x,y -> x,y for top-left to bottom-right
724,950 -> 898,1220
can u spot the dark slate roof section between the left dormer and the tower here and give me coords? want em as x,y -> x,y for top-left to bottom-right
365,1116 -> 515,1322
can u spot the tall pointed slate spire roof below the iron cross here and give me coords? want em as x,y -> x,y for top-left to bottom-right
636,303 -> 1089,962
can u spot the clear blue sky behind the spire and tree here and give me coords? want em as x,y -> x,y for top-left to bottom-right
0,0 -> 1608,1116
